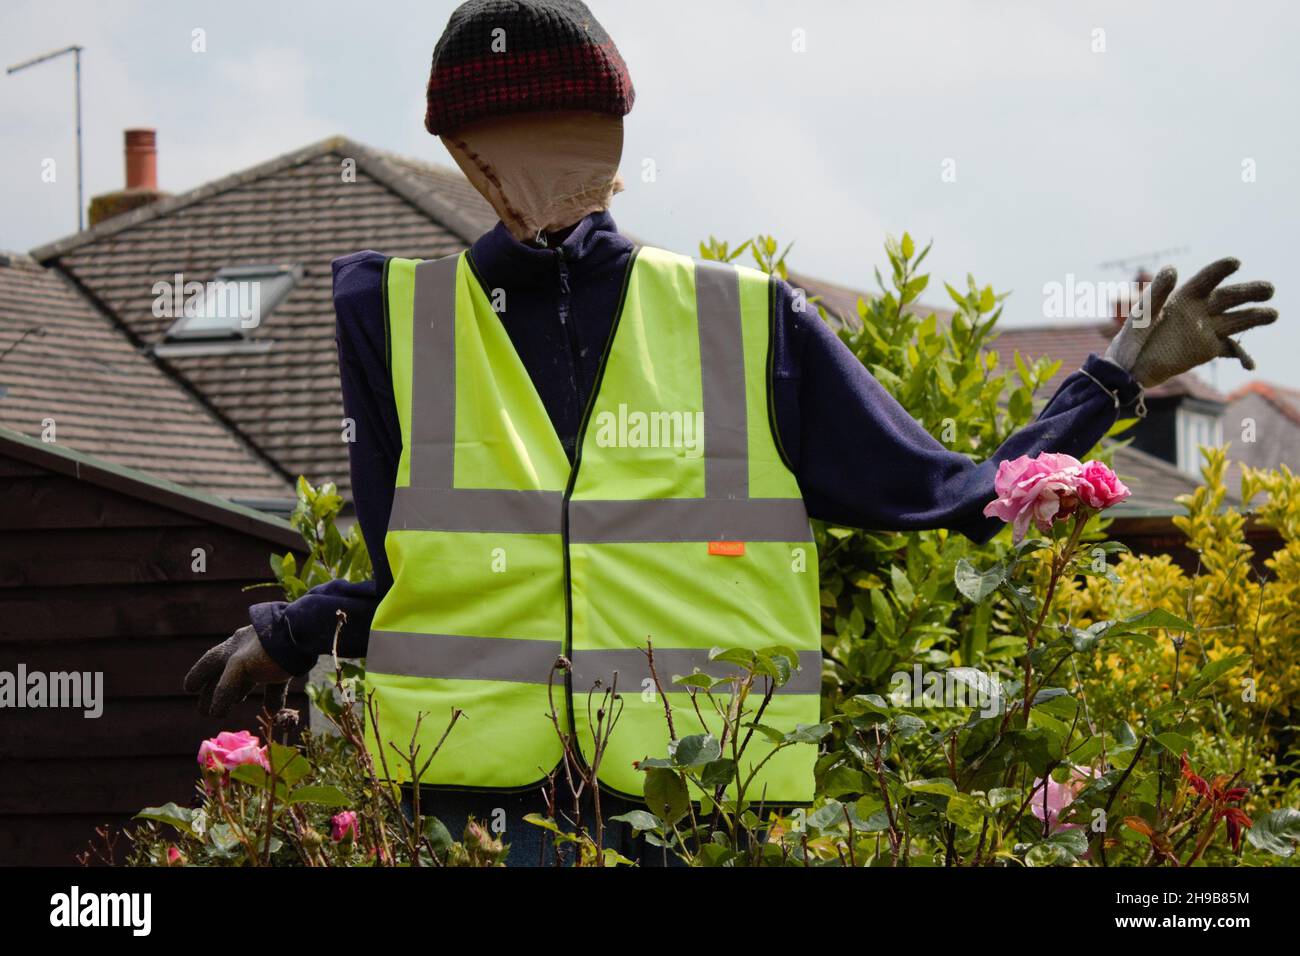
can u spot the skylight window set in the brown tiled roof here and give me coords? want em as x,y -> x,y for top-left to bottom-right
162,265 -> 302,343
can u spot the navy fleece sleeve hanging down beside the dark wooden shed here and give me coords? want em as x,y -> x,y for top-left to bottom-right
250,252 -> 402,674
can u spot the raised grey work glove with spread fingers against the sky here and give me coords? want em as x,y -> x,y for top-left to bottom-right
1104,259 -> 1278,388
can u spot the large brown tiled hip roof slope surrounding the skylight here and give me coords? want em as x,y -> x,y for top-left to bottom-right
33,137 -> 497,509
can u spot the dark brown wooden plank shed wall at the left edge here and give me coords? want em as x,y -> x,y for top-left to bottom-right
0,453 -> 306,865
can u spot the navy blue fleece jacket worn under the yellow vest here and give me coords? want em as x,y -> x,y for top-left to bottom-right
251,212 -> 1138,674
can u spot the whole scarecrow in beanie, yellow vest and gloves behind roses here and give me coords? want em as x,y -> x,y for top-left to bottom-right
185,0 -> 1277,856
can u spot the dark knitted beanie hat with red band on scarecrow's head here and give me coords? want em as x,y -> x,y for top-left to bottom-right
424,0 -> 636,135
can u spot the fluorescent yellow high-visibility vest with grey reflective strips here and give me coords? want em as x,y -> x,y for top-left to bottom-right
365,247 -> 822,803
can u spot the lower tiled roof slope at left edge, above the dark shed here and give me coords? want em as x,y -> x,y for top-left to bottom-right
0,254 -> 293,501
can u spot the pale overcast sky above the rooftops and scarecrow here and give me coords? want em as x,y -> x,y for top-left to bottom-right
0,0 -> 1300,389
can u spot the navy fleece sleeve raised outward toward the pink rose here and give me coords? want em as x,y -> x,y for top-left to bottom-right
772,282 -> 1138,541
